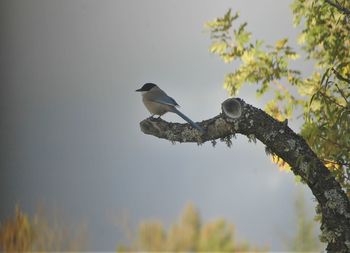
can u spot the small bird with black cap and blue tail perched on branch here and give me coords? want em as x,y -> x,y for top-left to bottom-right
136,83 -> 204,133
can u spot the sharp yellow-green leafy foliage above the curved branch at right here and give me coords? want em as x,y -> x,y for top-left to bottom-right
206,0 -> 350,196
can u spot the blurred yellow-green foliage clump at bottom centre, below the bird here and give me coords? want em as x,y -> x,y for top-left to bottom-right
118,204 -> 263,252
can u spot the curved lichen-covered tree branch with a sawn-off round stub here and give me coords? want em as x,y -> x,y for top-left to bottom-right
140,98 -> 350,252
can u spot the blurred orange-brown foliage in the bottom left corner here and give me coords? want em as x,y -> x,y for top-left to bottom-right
0,206 -> 86,252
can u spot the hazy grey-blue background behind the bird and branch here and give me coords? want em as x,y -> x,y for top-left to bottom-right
0,0 -> 314,251
